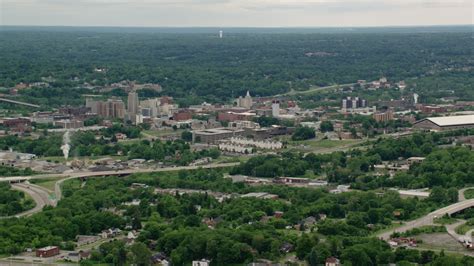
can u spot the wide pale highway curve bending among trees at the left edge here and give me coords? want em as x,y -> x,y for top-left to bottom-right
1,183 -> 56,218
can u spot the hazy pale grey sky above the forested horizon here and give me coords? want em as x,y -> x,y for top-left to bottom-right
0,0 -> 474,27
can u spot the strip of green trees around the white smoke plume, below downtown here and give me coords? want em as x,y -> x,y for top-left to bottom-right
0,132 -> 220,165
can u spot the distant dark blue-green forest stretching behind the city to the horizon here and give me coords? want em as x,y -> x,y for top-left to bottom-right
0,28 -> 473,104
